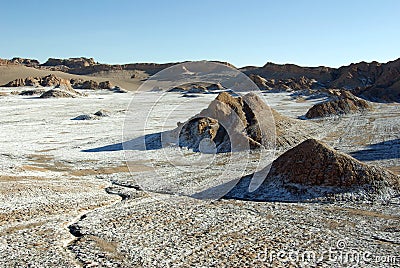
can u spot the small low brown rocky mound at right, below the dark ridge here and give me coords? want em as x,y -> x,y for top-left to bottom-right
305,90 -> 373,119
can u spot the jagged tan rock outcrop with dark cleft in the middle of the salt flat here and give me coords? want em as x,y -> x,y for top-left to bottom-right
175,92 -> 310,153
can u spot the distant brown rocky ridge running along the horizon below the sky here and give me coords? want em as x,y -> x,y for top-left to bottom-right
0,57 -> 400,102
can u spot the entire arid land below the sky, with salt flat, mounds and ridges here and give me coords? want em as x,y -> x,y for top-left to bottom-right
0,58 -> 400,267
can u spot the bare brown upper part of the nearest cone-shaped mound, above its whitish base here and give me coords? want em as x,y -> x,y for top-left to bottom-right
268,139 -> 400,189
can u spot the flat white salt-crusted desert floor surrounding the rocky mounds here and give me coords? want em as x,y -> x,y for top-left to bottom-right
0,88 -> 400,267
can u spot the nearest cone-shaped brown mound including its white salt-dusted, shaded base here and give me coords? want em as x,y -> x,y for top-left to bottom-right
227,139 -> 400,201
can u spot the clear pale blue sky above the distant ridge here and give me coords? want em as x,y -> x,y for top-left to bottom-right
0,0 -> 400,67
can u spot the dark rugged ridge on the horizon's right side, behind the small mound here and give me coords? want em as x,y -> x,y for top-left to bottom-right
244,59 -> 400,102
